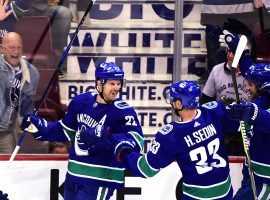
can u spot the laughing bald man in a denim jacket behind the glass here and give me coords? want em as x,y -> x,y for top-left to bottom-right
0,32 -> 39,153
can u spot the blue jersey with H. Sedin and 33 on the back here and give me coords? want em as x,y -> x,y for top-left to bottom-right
122,101 -> 239,199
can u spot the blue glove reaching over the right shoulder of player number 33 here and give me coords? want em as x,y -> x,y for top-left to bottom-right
226,102 -> 259,124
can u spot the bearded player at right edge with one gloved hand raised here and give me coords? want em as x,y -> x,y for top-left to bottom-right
221,31 -> 270,200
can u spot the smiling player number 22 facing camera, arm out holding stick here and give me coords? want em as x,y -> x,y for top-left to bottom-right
21,62 -> 143,200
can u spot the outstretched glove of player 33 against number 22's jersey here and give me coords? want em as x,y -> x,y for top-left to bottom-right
112,135 -> 136,162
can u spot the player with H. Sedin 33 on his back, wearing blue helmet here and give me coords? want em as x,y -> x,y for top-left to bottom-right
98,81 -> 239,200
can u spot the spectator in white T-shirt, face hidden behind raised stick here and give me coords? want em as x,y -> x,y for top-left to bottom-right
200,41 -> 249,155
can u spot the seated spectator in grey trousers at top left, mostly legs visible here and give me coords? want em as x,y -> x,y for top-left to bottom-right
27,0 -> 72,76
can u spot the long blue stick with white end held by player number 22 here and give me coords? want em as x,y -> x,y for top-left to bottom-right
8,0 -> 96,166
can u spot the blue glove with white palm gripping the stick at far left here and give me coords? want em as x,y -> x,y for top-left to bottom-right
20,114 -> 48,140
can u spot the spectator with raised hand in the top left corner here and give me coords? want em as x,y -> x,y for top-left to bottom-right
0,0 -> 31,43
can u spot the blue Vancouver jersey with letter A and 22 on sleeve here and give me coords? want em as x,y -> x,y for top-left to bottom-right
39,93 -> 143,188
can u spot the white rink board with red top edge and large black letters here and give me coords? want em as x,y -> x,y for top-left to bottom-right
0,155 -> 243,200
